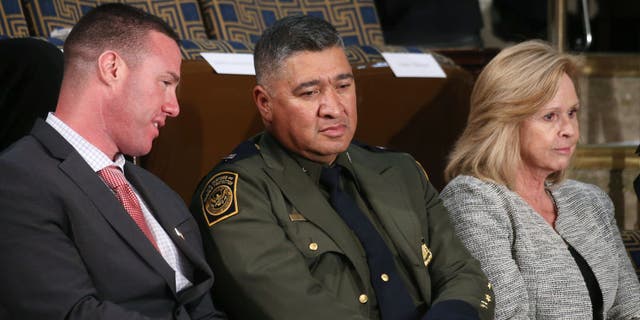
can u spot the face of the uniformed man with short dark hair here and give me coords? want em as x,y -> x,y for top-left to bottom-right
254,47 -> 358,164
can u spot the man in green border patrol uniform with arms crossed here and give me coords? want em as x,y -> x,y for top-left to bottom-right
191,16 -> 494,320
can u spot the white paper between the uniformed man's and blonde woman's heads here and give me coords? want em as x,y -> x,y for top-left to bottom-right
382,52 -> 447,78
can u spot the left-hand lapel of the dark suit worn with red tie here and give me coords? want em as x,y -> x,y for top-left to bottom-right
31,121 -> 175,292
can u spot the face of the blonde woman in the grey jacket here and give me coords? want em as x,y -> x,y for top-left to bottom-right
520,74 -> 580,177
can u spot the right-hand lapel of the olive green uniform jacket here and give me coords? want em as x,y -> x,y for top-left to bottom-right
349,148 -> 422,264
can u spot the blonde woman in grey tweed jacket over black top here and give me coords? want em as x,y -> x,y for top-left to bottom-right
441,41 -> 640,319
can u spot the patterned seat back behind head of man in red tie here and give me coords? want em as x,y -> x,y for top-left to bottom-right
23,0 -> 206,39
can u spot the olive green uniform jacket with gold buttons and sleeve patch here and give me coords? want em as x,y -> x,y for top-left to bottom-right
191,134 -> 493,320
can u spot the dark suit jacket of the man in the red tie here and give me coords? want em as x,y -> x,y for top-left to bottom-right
0,120 -> 225,320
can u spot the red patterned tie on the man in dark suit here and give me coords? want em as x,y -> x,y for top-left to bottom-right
98,166 -> 160,251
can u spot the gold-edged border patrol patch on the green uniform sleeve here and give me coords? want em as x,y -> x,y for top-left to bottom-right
200,171 -> 238,227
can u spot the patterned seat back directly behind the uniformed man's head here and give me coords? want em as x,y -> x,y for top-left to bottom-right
200,0 -> 384,45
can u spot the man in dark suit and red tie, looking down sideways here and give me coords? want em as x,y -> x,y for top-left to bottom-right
0,4 -> 223,320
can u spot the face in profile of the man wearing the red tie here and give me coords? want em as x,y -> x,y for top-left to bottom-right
105,31 -> 182,156
